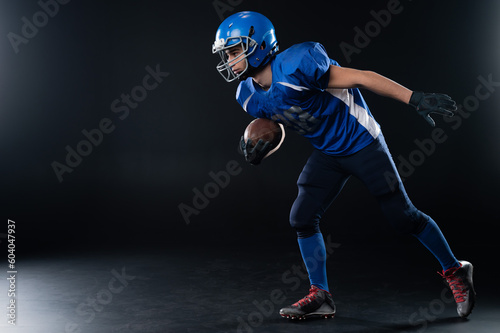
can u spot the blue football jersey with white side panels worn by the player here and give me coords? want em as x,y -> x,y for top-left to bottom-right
236,42 -> 380,156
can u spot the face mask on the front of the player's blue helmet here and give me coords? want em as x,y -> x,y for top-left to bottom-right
212,36 -> 257,82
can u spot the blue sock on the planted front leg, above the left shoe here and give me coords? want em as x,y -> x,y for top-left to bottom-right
297,233 -> 329,291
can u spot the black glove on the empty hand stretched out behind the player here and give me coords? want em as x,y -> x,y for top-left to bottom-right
409,91 -> 457,126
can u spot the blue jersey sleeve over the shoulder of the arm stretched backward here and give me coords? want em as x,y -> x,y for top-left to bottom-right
291,42 -> 332,90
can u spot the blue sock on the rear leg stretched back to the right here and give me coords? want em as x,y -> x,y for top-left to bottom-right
415,218 -> 460,270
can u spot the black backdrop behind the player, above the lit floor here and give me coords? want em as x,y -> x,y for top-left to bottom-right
0,0 -> 500,254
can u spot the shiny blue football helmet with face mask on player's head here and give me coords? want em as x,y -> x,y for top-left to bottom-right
212,12 -> 278,82
